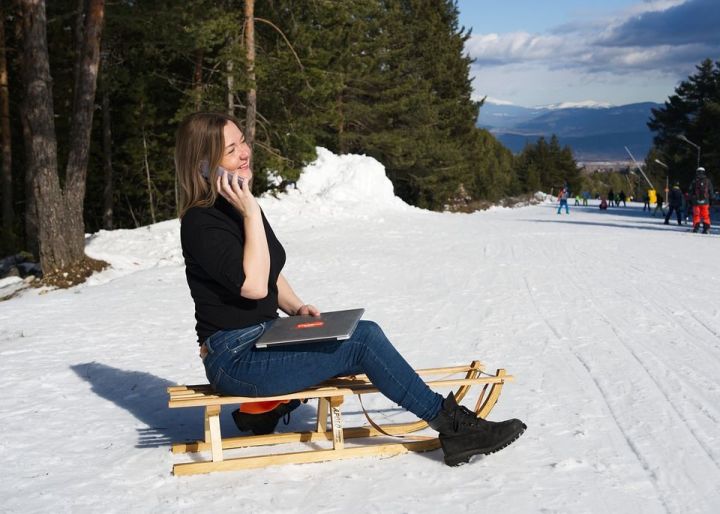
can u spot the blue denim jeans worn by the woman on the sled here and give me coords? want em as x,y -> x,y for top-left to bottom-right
203,320 -> 443,421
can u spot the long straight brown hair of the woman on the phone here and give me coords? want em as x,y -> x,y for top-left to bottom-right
175,112 -> 241,218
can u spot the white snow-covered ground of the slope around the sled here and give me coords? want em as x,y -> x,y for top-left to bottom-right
0,151 -> 720,514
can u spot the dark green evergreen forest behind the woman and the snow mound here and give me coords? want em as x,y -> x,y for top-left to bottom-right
3,0 -> 518,260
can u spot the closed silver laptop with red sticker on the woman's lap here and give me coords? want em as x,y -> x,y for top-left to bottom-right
255,309 -> 365,348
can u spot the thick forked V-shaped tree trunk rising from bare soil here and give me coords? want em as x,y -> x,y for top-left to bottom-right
19,0 -> 105,273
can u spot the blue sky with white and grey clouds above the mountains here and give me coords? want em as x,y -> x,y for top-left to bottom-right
458,0 -> 720,106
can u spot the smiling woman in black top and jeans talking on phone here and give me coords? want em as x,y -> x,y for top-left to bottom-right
175,113 -> 526,465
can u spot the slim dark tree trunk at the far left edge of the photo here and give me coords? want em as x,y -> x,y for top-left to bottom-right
0,5 -> 15,231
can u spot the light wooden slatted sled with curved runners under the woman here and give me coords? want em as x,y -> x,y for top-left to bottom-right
168,361 -> 513,475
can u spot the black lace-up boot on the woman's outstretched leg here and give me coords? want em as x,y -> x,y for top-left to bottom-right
428,393 -> 527,466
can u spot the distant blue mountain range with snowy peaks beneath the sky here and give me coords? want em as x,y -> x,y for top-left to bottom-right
477,101 -> 662,162
